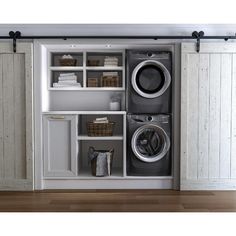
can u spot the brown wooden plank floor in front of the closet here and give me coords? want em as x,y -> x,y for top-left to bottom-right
0,190 -> 236,212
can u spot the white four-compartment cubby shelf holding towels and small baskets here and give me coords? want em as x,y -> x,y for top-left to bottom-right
48,50 -> 125,91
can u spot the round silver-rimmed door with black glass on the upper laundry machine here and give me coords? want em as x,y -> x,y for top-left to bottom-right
131,60 -> 171,98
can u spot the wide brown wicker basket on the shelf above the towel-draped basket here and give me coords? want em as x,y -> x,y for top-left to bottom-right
87,122 -> 115,136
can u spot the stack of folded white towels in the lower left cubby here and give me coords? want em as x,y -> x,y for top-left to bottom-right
53,73 -> 81,87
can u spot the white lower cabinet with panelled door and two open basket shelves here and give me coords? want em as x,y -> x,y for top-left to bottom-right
43,112 -> 126,179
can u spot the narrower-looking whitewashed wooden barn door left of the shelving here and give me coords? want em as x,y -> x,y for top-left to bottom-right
0,43 -> 33,190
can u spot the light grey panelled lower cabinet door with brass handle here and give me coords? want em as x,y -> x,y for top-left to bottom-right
43,115 -> 77,177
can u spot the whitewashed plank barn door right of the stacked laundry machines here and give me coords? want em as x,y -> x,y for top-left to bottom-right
181,43 -> 236,190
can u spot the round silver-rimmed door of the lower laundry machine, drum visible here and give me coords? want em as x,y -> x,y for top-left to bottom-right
131,124 -> 170,162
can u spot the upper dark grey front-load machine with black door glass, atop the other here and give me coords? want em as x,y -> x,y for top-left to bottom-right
127,49 -> 172,114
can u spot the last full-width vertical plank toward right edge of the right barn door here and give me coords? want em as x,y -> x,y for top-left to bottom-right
220,54 -> 232,178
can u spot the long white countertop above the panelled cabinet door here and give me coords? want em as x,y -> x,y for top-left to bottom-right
43,111 -> 126,115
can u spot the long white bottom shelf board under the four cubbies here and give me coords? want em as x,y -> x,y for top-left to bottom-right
48,87 -> 125,92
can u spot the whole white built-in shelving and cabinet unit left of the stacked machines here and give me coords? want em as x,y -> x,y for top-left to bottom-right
34,40 -> 172,189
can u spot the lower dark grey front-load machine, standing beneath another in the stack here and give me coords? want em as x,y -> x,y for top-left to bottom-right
126,114 -> 171,176
